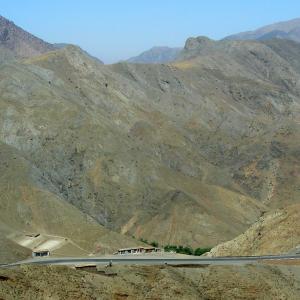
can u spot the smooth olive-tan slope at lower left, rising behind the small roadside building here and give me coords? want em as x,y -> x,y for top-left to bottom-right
0,144 -> 132,255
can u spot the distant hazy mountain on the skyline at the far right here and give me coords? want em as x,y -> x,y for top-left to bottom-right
225,19 -> 300,42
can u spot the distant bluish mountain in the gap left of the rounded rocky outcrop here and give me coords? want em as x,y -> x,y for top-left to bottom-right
127,47 -> 182,64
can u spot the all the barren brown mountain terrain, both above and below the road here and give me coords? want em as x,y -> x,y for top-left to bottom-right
0,17 -> 300,299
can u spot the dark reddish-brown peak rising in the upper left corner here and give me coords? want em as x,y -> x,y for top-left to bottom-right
0,16 -> 55,58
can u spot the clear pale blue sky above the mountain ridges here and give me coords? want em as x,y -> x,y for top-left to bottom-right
0,0 -> 300,63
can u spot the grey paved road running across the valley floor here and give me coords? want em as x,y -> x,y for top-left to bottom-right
0,255 -> 300,268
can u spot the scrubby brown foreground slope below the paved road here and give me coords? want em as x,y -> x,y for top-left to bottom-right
0,265 -> 300,300
